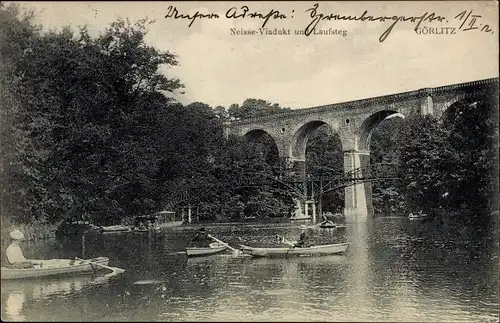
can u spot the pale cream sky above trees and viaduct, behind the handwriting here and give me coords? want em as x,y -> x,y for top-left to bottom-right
11,1 -> 499,109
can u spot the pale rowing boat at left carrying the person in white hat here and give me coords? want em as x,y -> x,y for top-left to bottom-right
1,257 -> 109,280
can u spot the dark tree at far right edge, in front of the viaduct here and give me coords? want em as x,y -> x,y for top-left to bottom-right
443,99 -> 498,221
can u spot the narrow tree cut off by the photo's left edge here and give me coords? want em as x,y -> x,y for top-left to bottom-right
0,3 -> 44,221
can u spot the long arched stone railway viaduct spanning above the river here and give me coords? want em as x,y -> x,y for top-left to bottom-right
225,78 -> 499,221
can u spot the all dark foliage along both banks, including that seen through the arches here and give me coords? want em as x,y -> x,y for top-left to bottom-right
0,4 -> 497,228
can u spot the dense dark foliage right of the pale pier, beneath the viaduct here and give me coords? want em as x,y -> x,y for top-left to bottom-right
371,96 -> 498,223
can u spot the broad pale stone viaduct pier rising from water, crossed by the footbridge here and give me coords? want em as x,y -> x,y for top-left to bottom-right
344,150 -> 373,222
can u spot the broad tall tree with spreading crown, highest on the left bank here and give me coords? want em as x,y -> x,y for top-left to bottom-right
1,5 -> 186,225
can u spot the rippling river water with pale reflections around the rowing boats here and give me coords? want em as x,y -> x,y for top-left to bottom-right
1,217 -> 499,322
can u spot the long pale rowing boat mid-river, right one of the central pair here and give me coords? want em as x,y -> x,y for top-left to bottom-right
240,243 -> 350,257
